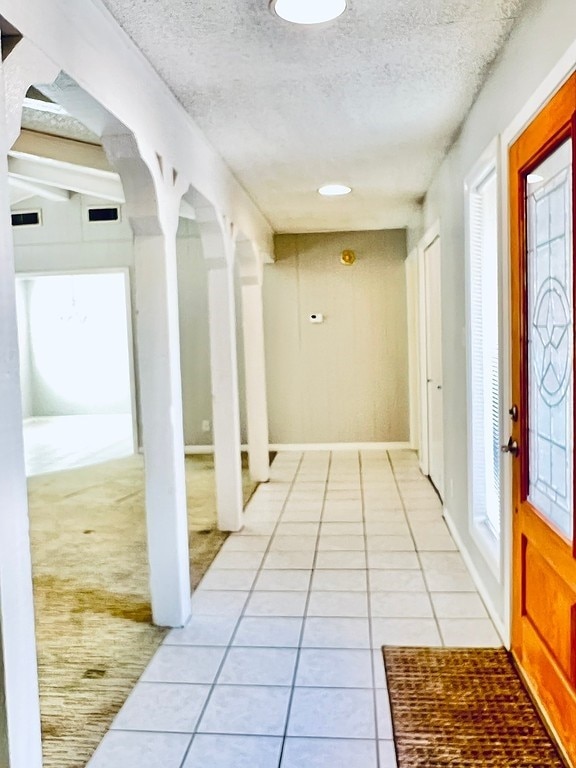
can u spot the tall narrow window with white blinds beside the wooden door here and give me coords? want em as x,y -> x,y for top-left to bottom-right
467,158 -> 501,569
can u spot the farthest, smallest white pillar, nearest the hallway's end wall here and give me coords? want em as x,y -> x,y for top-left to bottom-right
237,242 -> 270,483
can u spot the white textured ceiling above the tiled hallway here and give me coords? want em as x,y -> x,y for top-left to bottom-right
92,0 -> 526,232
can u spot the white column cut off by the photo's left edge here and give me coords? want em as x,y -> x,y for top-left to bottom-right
0,61 -> 42,768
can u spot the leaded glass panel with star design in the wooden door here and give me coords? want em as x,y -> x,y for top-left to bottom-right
525,139 -> 574,540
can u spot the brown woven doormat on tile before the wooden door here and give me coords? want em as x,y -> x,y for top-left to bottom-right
383,646 -> 564,768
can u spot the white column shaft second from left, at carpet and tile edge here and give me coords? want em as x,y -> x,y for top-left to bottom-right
134,220 -> 190,627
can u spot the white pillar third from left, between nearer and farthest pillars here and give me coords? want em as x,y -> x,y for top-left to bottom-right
196,206 -> 244,531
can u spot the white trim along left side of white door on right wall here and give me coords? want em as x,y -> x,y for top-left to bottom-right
417,219 -> 444,488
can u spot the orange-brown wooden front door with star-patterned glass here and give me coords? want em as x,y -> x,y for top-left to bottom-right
509,75 -> 576,765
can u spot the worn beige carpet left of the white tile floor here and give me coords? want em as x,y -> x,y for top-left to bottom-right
28,456 -> 255,768
